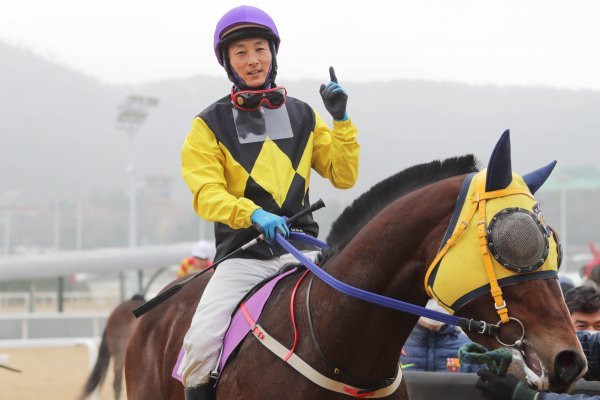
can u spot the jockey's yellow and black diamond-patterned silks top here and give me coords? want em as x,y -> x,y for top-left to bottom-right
181,96 -> 360,259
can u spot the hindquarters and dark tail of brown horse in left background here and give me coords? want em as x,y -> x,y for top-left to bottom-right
79,294 -> 146,400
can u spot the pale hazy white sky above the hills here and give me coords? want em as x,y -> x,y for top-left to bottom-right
0,0 -> 600,90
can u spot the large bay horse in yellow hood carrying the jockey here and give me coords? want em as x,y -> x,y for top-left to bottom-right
125,132 -> 586,400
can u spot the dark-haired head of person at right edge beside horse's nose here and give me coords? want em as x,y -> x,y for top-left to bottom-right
565,286 -> 600,331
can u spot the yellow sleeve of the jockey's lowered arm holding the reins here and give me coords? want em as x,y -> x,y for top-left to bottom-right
181,117 -> 260,229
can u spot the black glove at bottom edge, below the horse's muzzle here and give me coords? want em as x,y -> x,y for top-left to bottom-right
475,369 -> 539,400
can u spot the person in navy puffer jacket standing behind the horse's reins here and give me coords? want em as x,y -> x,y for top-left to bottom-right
400,300 -> 479,372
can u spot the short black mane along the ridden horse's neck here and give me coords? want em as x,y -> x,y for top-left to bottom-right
326,154 -> 478,258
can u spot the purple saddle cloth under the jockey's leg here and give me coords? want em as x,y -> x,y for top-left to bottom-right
171,268 -> 297,382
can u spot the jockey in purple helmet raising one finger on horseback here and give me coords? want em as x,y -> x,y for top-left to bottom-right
179,6 -> 359,400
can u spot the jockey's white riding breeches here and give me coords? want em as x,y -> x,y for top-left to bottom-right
179,251 -> 319,388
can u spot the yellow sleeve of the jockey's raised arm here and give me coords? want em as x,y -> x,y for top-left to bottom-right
312,112 -> 360,189
